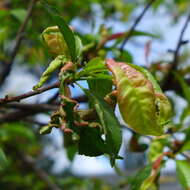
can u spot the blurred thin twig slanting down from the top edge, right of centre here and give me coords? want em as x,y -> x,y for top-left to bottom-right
120,0 -> 156,53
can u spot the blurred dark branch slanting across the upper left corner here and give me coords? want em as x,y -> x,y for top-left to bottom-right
0,0 -> 37,85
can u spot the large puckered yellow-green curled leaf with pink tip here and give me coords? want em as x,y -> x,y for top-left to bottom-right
106,59 -> 171,136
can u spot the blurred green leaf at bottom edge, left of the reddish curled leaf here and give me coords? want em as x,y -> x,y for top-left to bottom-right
131,165 -> 152,190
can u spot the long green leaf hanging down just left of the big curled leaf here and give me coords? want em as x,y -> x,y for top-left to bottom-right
82,88 -> 122,166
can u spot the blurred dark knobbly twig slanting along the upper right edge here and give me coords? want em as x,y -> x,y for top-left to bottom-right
161,13 -> 190,90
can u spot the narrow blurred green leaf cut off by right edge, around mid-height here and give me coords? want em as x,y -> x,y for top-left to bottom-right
173,72 -> 190,104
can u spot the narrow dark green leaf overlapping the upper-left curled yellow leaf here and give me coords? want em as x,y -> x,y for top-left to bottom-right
42,1 -> 79,62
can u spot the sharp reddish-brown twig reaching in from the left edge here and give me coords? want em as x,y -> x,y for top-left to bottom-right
0,82 -> 59,105
